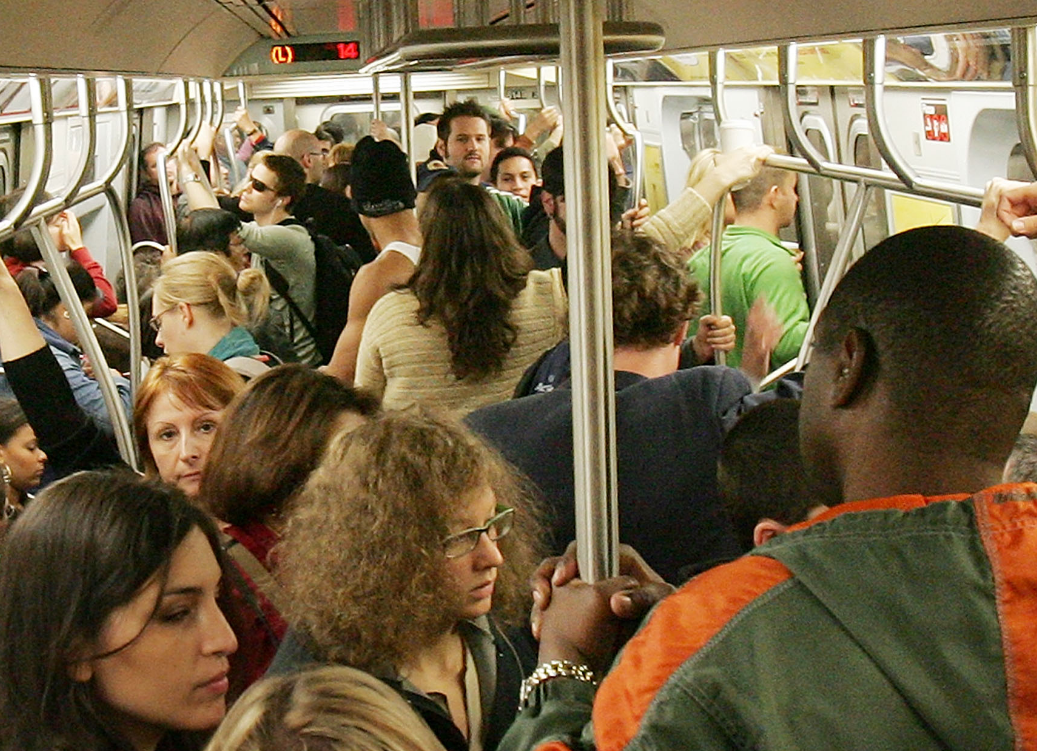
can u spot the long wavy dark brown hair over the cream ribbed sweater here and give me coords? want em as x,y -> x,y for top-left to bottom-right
407,177 -> 533,380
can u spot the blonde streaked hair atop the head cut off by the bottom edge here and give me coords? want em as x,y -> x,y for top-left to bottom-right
206,665 -> 444,751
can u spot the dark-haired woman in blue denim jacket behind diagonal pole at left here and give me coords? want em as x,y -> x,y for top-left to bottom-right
17,261 -> 131,435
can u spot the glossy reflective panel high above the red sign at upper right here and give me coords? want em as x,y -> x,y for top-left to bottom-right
886,29 -> 1012,81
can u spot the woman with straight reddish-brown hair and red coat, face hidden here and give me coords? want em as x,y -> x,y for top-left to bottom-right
198,364 -> 377,683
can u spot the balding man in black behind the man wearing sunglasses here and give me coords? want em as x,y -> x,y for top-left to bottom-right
274,128 -> 376,261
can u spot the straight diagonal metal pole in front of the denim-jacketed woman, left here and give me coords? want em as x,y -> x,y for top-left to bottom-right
31,219 -> 137,467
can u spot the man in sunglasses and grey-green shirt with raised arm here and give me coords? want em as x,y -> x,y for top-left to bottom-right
177,144 -> 321,365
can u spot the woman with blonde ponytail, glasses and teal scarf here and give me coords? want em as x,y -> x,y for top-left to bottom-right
150,252 -> 270,361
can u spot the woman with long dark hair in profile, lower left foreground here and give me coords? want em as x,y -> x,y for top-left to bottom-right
0,472 -> 237,751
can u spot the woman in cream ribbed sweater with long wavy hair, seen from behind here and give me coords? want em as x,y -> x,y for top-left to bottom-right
356,178 -> 566,413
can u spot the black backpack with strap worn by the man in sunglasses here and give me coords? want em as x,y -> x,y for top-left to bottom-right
265,219 -> 364,364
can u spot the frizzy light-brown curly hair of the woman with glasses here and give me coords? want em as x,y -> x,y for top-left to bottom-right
280,409 -> 542,674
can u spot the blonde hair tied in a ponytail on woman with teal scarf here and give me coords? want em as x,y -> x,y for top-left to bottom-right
155,251 -> 270,326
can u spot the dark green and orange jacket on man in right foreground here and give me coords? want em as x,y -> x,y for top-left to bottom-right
500,483 -> 1037,751
